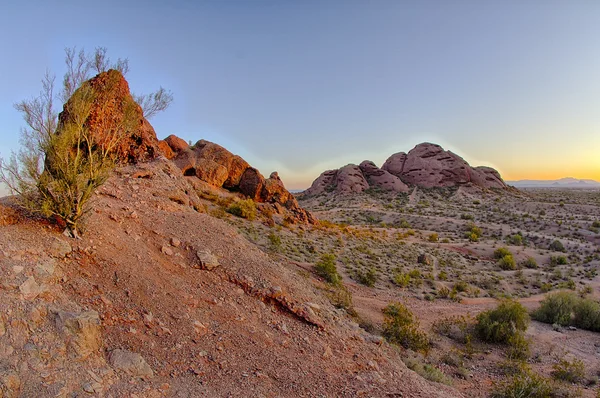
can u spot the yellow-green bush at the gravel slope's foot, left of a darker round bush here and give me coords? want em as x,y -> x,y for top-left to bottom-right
383,303 -> 430,353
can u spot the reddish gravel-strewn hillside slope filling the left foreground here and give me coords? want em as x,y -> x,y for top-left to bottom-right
0,159 -> 458,397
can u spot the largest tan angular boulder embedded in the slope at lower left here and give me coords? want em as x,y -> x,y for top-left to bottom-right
52,310 -> 100,359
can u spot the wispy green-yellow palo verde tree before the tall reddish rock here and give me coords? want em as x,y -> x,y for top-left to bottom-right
0,47 -> 173,237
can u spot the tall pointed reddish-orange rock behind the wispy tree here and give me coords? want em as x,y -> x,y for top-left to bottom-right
57,69 -> 161,163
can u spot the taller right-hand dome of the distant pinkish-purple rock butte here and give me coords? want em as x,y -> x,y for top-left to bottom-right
382,143 -> 506,188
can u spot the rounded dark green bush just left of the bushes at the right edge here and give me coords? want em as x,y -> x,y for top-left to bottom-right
475,300 -> 529,344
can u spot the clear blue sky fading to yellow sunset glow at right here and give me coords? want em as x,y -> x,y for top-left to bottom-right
0,0 -> 600,196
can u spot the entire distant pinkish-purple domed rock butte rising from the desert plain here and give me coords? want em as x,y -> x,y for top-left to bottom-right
304,143 -> 507,196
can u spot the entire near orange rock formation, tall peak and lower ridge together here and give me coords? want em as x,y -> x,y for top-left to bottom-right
58,70 -> 316,223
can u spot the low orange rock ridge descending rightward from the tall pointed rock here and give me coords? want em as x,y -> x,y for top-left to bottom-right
165,136 -> 316,223
